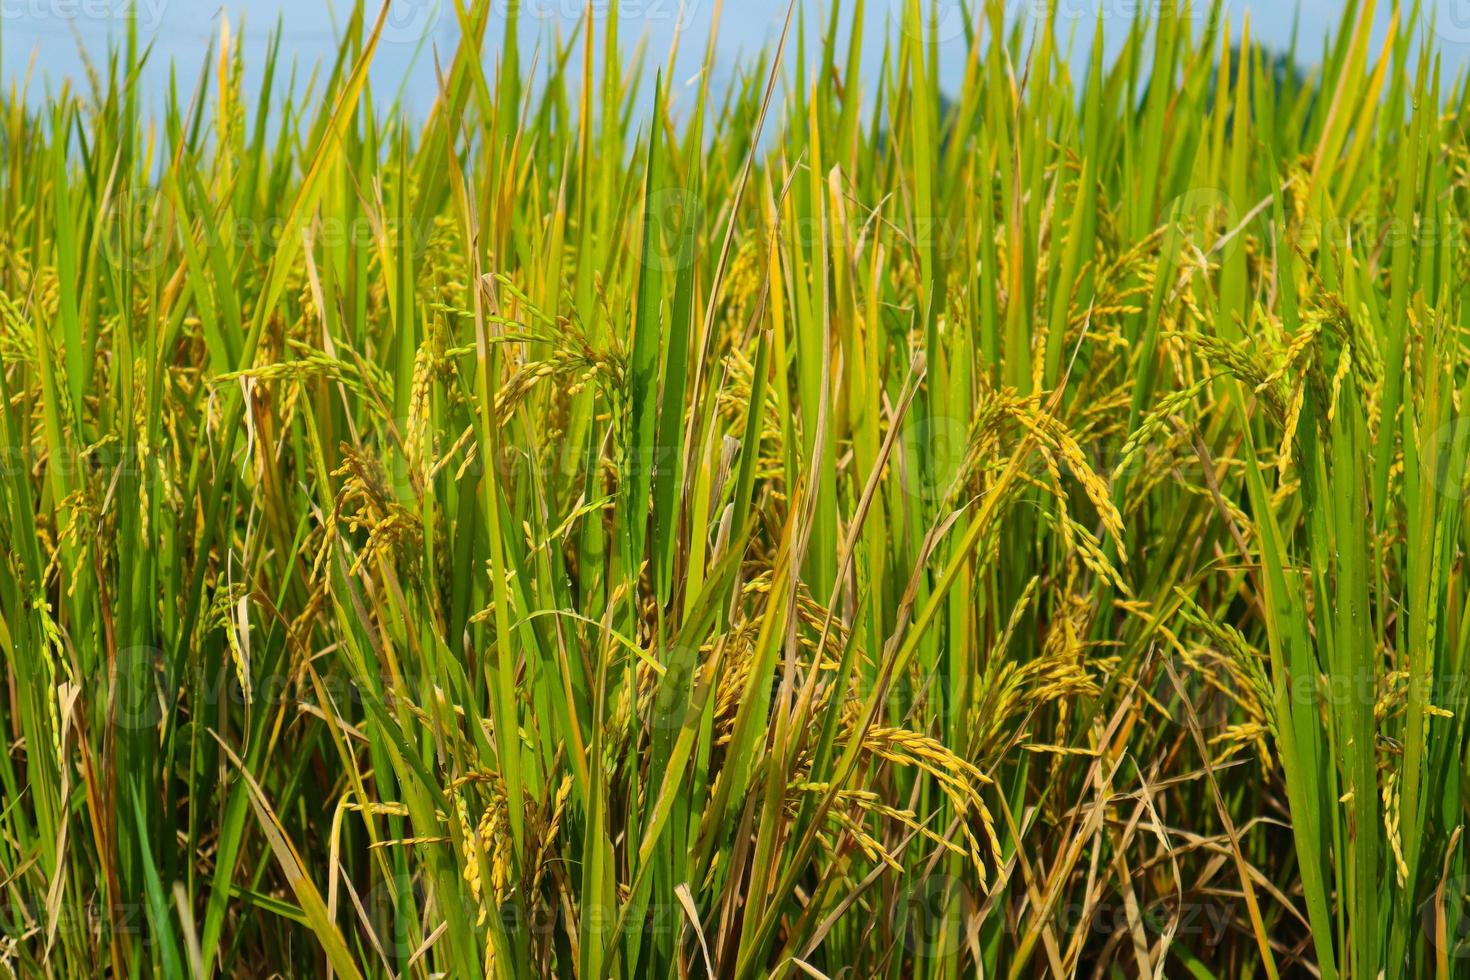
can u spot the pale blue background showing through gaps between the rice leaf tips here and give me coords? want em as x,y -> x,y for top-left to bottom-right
0,0 -> 1434,113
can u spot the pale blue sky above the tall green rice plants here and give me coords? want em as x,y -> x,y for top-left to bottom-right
0,0 -> 1470,110
